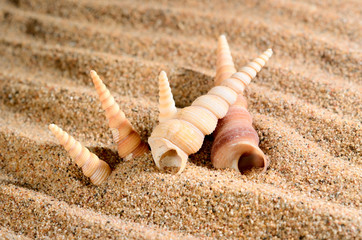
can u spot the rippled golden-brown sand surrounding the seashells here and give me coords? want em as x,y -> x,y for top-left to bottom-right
0,0 -> 362,239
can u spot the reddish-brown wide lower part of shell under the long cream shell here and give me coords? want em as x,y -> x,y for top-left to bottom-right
211,95 -> 268,173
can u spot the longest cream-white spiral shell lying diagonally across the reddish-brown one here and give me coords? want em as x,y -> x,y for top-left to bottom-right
148,50 -> 271,173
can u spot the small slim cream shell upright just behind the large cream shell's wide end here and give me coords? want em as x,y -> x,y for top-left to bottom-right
158,71 -> 177,122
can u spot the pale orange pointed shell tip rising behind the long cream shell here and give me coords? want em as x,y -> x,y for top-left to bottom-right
215,35 -> 236,86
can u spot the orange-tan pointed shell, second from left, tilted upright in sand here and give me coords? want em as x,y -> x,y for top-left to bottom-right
90,70 -> 148,158
